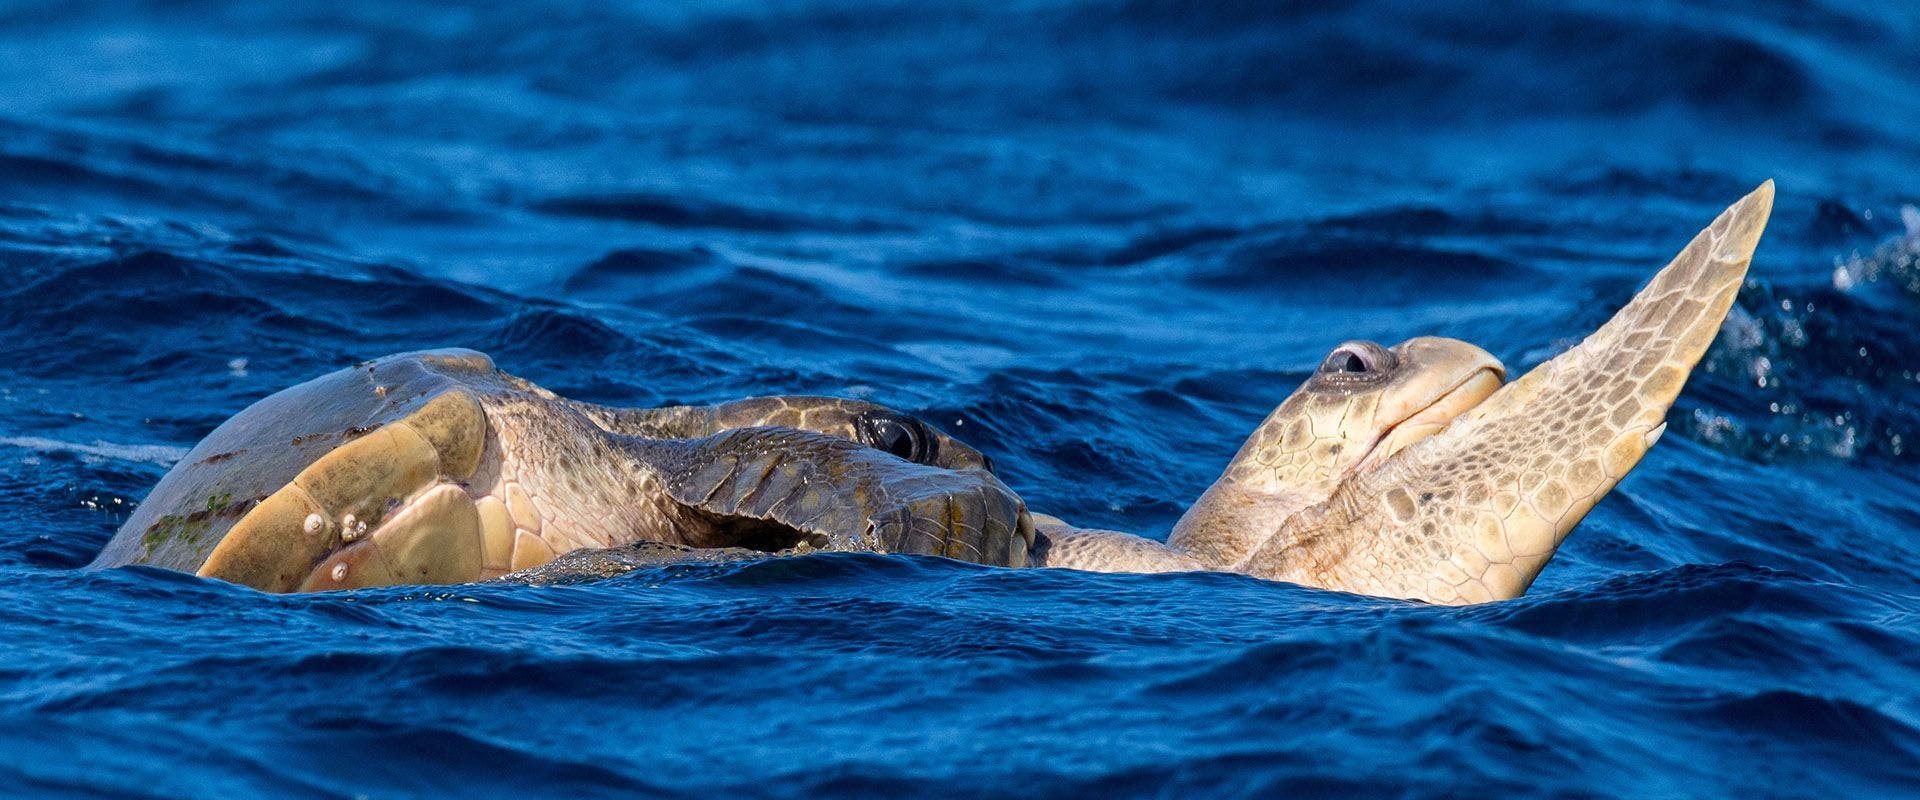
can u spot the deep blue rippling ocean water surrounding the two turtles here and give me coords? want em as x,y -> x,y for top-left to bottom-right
0,0 -> 1920,798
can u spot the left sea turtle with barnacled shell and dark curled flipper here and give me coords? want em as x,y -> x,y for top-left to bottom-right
92,349 -> 1033,591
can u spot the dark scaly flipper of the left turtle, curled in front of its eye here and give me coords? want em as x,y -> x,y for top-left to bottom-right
624,428 -> 1033,566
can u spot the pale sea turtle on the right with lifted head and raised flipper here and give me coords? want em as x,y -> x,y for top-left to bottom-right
520,180 -> 1774,604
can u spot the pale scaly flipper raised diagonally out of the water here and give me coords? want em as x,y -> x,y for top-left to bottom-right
1252,180 -> 1774,602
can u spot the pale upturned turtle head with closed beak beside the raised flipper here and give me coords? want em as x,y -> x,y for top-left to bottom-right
1223,336 -> 1505,499
